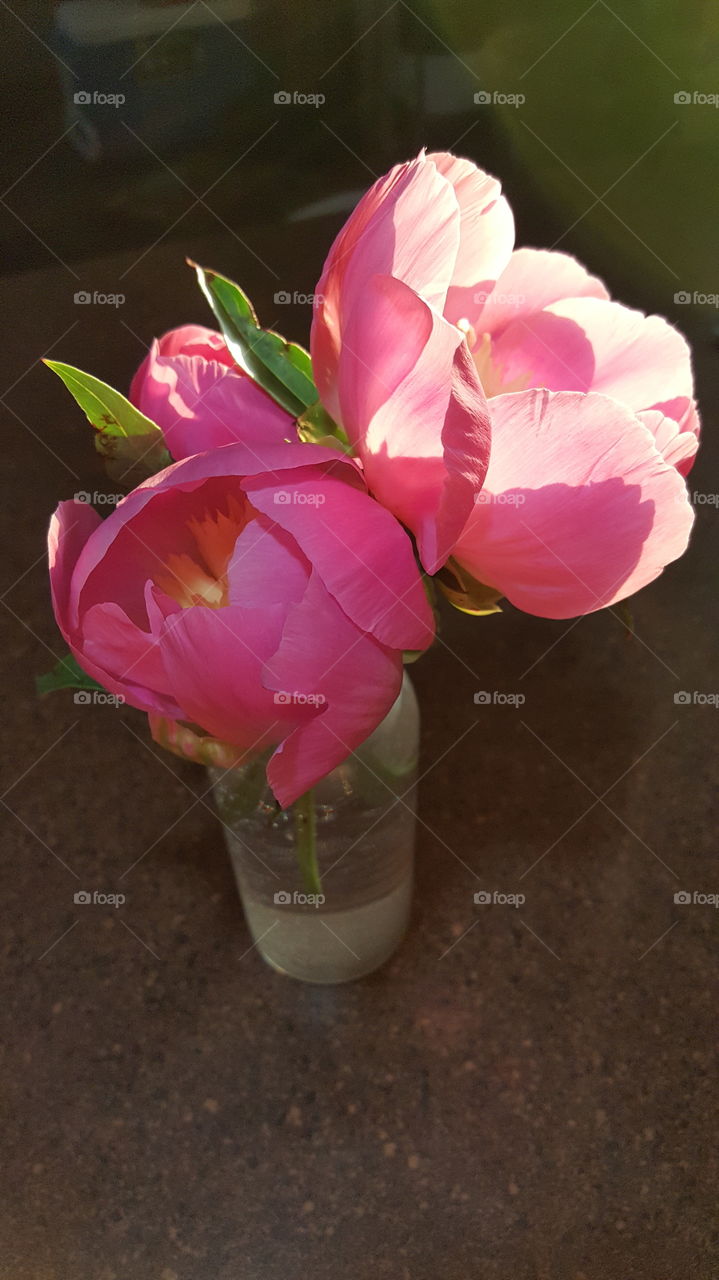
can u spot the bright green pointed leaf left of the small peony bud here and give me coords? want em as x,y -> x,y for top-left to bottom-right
45,360 -> 173,486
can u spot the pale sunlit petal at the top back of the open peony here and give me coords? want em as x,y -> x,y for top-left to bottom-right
424,151 -> 514,324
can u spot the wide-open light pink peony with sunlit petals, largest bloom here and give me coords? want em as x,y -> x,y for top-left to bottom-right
312,154 -> 699,617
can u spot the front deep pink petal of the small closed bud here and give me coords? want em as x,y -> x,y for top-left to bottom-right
136,356 -> 294,460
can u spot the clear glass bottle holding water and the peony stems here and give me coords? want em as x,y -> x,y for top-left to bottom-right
209,672 -> 420,983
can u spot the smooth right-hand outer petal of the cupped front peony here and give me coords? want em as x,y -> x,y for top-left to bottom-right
243,467 -> 434,649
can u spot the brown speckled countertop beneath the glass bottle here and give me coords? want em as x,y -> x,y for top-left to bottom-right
0,229 -> 719,1280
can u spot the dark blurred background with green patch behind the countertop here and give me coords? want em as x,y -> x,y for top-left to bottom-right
0,0 -> 719,320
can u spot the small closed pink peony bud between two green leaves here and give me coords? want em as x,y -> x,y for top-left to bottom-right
129,325 -> 297,461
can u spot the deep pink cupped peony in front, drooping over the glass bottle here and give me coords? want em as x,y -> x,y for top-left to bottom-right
49,444 -> 434,806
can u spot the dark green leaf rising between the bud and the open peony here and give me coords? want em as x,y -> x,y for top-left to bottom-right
189,262 -> 317,417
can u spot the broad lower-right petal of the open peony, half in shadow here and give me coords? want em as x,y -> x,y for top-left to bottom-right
455,390 -> 693,618
